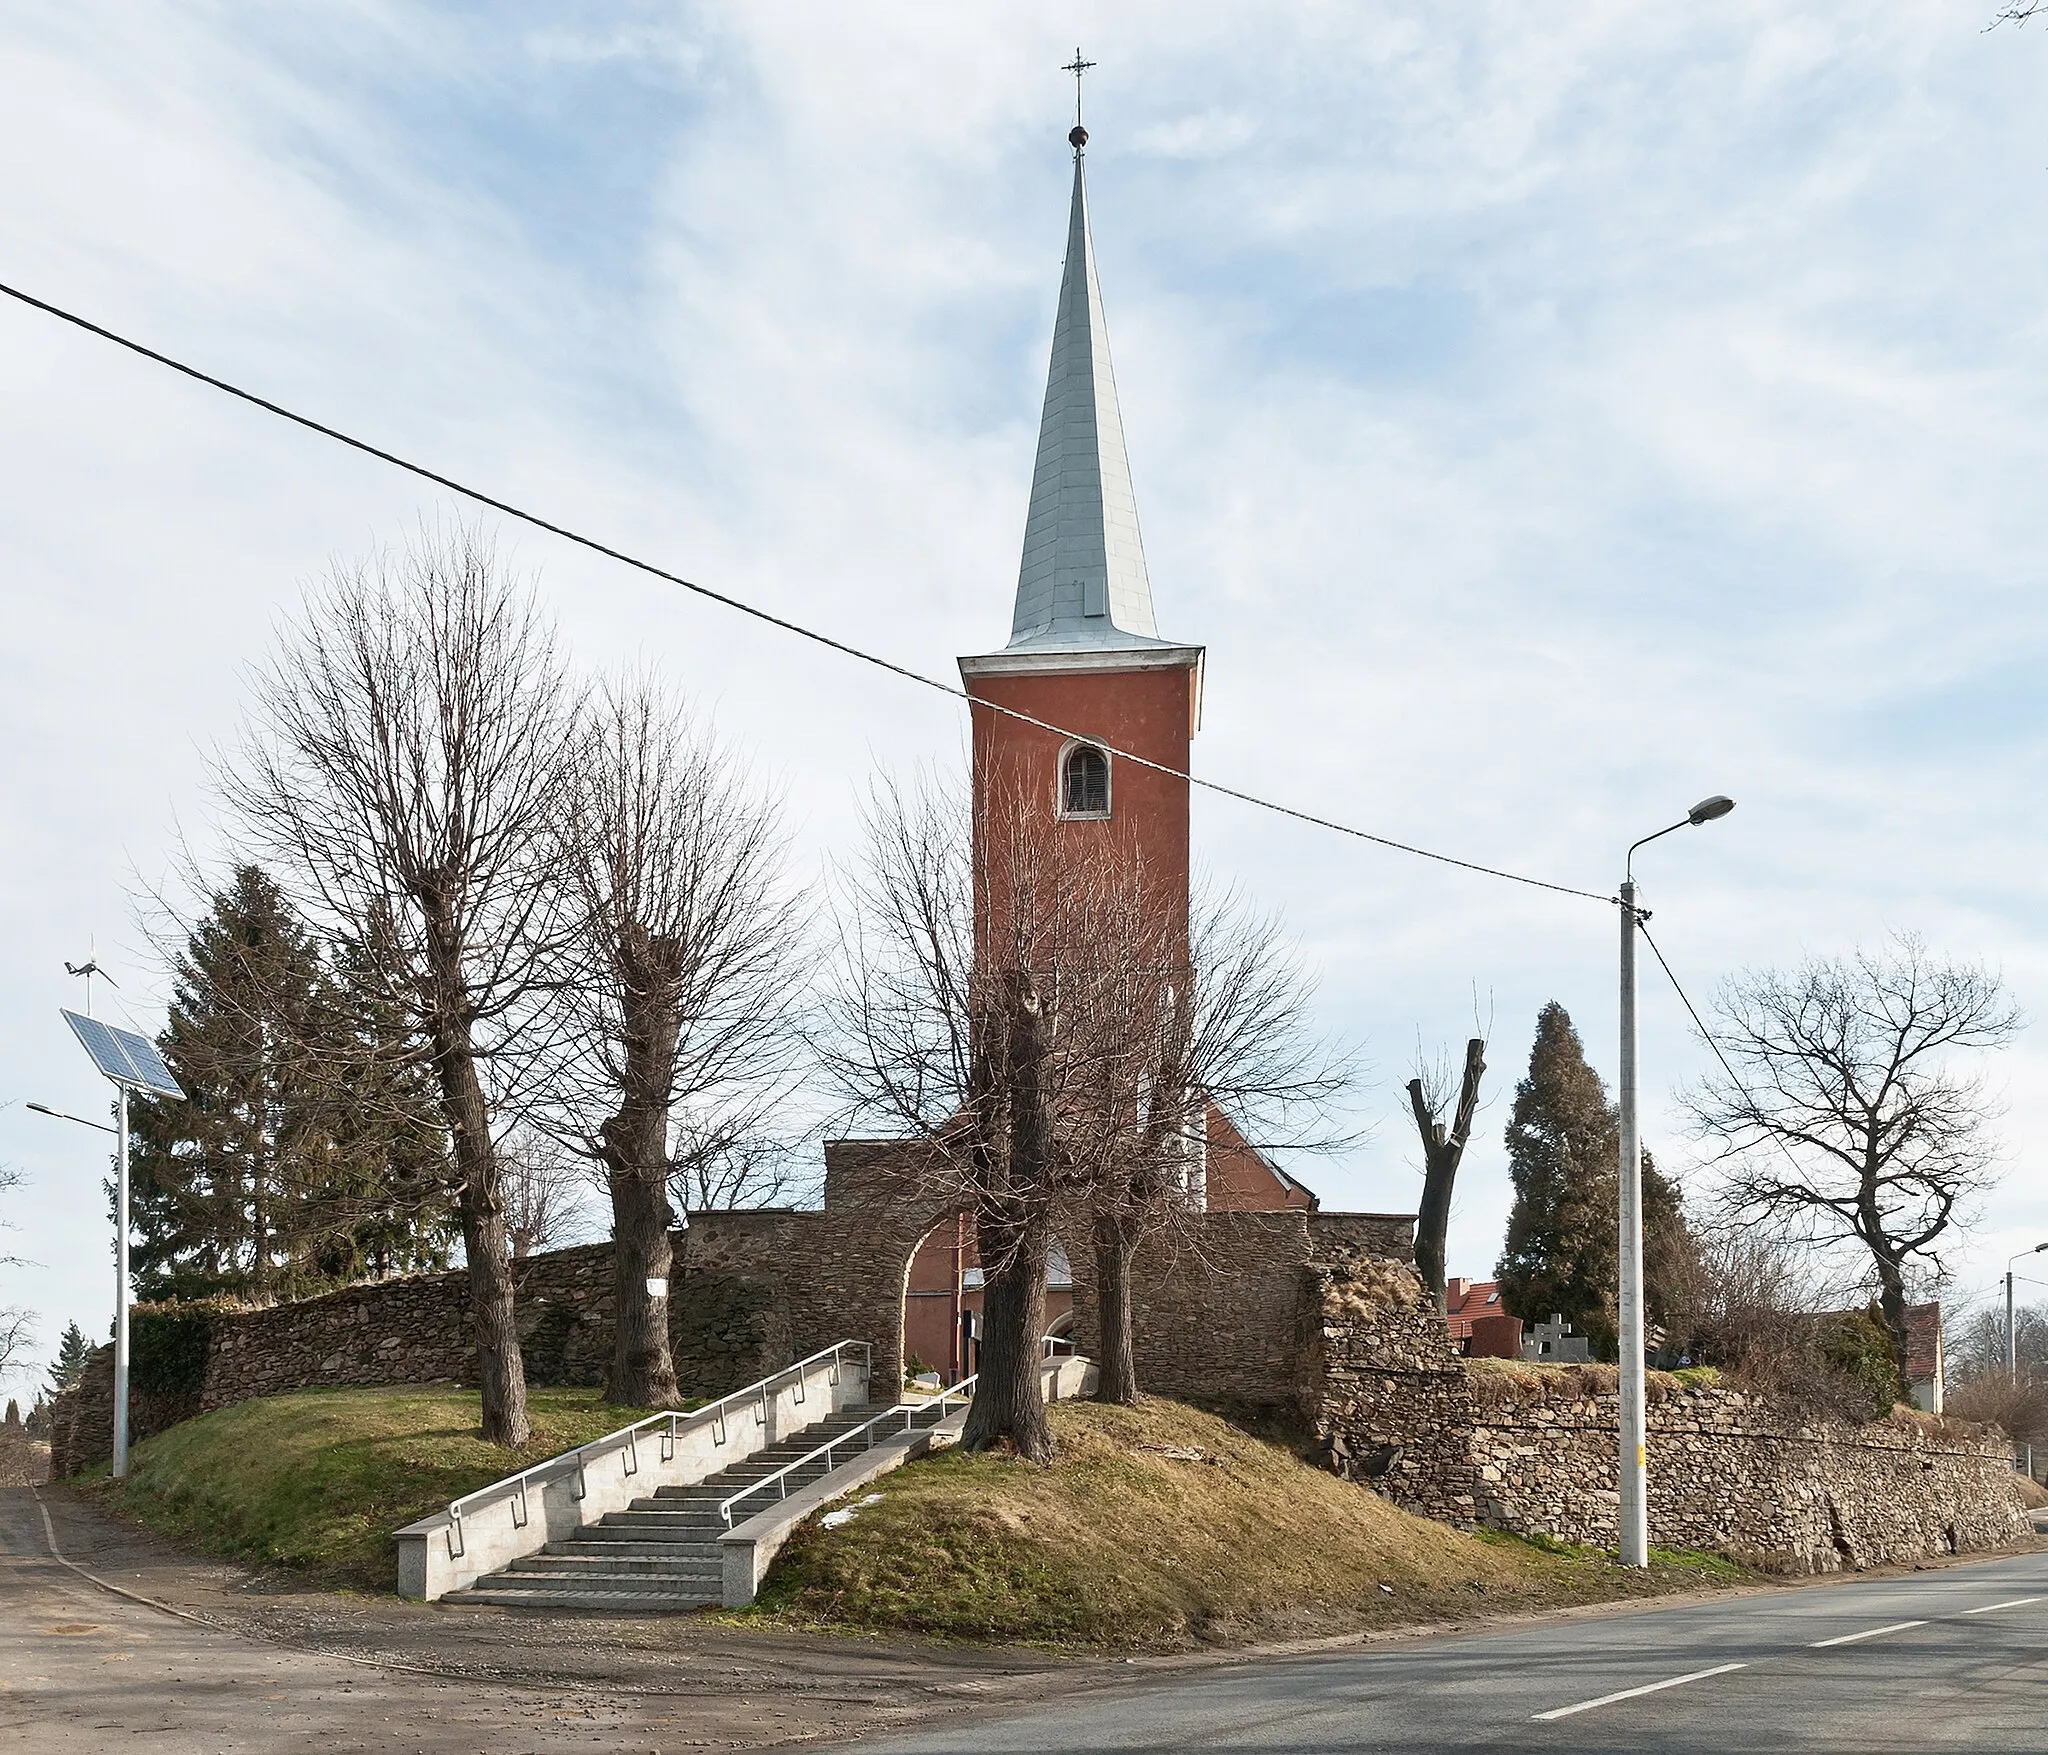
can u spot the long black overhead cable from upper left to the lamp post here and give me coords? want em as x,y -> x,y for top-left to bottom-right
0,283 -> 1613,905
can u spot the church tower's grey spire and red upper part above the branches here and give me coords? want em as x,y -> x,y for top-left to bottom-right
961,125 -> 1202,965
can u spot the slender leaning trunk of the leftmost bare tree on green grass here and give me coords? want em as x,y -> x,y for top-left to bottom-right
434,970 -> 532,1450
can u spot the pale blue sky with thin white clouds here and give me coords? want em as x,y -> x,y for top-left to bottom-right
0,0 -> 2048,1367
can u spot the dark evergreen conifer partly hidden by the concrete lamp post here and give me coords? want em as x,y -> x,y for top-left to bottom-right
1493,999 -> 1692,1358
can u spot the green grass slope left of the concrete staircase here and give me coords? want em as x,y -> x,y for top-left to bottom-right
94,1386 -> 641,1591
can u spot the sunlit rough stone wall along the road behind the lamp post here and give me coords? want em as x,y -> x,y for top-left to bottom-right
1313,1259 -> 2028,1573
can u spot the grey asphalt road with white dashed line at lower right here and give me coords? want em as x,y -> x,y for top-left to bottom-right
831,1552 -> 2048,1755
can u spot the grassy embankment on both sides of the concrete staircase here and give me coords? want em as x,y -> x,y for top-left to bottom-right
92,1388 -> 1741,1649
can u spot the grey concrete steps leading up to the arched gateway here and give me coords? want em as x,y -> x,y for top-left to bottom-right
442,1407 -> 881,1614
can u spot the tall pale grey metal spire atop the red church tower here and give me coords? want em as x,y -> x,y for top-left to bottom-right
1008,143 -> 1159,651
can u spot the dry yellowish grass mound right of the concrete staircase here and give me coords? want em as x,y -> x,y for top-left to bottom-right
748,1401 -> 1737,1649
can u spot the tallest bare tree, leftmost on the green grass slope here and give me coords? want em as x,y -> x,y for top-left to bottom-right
221,516 -> 573,1446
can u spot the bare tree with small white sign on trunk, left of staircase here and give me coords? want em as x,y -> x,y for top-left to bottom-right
555,680 -> 803,1407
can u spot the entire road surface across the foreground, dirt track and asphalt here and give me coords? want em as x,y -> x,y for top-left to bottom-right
0,1491 -> 2048,1755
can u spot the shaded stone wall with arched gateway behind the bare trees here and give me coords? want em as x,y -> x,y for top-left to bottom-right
57,1141 -> 1413,1474
